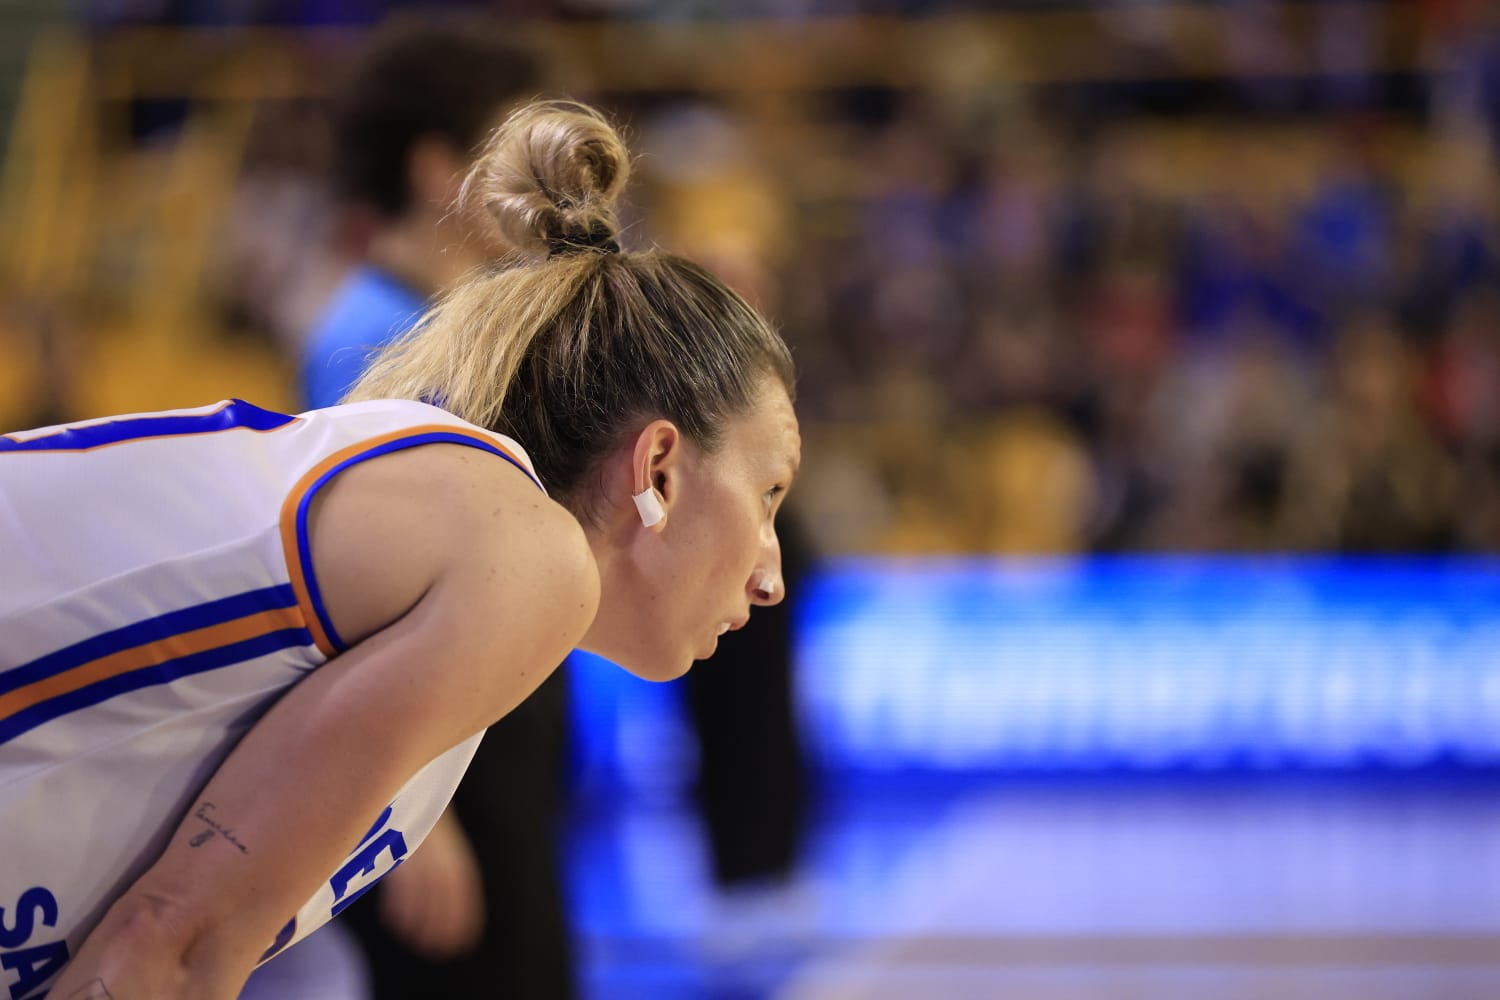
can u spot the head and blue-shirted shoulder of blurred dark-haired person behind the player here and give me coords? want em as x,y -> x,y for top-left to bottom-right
302,18 -> 537,406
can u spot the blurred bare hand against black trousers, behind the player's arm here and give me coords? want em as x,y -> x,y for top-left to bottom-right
380,810 -> 485,960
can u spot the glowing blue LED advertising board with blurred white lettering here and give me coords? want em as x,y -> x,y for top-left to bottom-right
798,556 -> 1500,772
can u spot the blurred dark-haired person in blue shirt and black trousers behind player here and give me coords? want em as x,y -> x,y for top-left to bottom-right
302,19 -> 575,1000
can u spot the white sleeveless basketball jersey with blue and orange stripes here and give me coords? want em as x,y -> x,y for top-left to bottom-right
0,400 -> 540,1000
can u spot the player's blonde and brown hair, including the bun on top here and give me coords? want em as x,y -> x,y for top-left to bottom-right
345,102 -> 795,513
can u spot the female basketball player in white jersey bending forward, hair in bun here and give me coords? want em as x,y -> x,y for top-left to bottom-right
0,103 -> 800,1000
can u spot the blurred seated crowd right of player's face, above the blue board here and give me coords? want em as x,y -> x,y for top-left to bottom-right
762,102 -> 1500,563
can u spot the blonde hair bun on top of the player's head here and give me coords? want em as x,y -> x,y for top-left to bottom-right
461,100 -> 630,256
